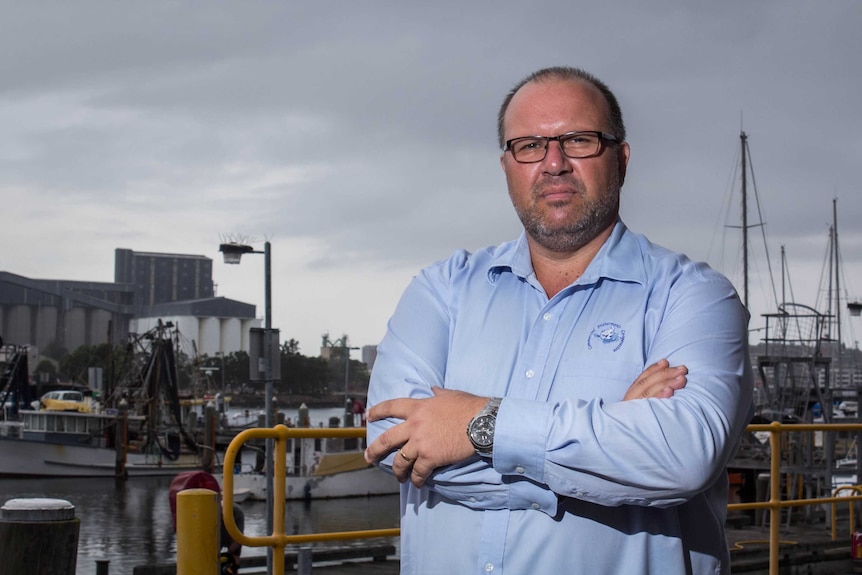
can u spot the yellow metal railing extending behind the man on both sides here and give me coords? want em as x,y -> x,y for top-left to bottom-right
187,423 -> 862,575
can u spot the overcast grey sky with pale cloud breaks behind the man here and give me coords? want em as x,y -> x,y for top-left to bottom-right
0,0 -> 862,357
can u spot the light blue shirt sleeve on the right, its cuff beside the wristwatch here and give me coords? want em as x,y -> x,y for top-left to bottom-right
494,274 -> 752,507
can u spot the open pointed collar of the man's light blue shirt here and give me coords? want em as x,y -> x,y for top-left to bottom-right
488,219 -> 646,284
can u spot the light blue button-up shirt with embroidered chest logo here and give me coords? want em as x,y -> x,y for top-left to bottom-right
368,222 -> 752,575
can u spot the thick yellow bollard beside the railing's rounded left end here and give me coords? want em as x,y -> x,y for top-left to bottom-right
177,489 -> 219,575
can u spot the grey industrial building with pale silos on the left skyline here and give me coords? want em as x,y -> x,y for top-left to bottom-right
0,248 -> 260,355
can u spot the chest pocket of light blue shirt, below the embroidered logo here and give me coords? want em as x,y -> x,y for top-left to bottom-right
549,357 -> 644,401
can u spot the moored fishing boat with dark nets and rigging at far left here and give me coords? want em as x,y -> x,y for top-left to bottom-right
0,322 -> 215,478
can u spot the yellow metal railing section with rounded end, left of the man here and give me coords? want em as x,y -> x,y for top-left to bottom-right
222,425 -> 401,575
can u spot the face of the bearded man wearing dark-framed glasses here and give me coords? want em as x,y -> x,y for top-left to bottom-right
500,80 -> 629,252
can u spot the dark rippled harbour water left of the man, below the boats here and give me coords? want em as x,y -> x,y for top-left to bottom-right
0,410 -> 398,575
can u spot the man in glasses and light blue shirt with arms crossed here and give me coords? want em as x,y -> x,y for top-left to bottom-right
366,68 -> 752,575
